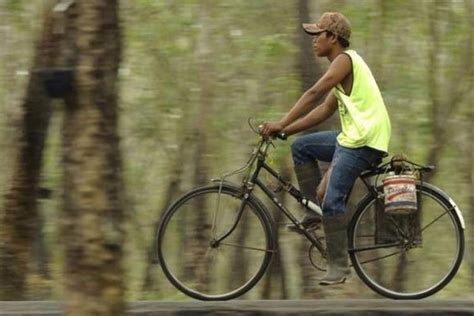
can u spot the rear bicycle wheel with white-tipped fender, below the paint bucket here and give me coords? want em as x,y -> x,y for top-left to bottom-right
349,184 -> 464,299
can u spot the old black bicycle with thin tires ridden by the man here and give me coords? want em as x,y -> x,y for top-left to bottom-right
156,122 -> 465,300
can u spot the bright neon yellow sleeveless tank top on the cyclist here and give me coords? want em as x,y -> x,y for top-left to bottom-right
332,50 -> 391,152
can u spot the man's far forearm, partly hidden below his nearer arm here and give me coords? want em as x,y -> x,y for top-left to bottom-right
282,93 -> 337,135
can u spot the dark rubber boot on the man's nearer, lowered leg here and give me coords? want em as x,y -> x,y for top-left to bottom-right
319,214 -> 351,285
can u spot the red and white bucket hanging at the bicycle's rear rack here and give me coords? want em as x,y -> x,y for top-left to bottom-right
383,174 -> 418,215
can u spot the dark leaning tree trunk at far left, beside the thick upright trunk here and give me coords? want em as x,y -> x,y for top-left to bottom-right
0,1 -> 58,300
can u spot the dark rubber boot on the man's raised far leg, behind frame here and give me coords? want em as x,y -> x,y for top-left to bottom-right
286,161 -> 321,232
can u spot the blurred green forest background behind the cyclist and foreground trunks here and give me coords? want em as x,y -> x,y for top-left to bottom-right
0,0 -> 474,300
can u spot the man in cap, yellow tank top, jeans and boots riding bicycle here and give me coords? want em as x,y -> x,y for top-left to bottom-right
261,12 -> 391,285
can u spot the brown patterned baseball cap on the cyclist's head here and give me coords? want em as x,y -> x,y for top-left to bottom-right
303,12 -> 351,41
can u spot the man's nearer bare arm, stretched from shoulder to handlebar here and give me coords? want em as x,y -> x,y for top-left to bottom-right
261,54 -> 352,137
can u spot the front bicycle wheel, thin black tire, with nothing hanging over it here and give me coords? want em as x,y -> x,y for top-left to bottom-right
157,184 -> 275,300
